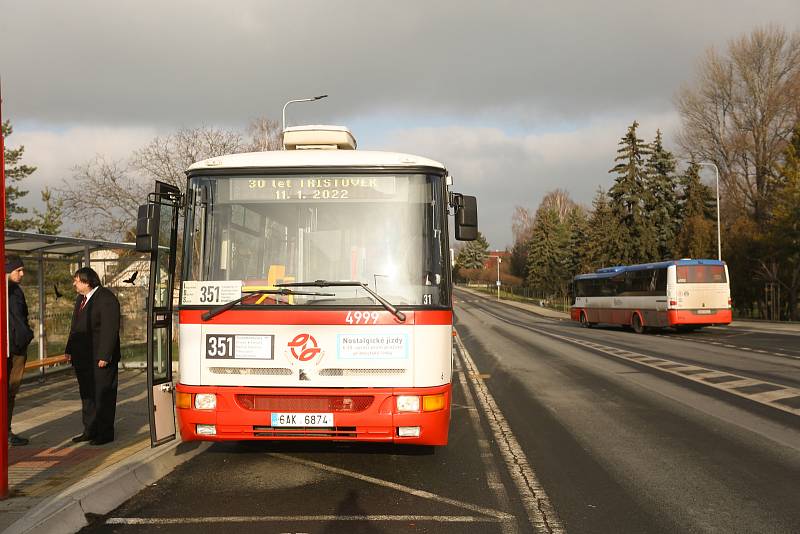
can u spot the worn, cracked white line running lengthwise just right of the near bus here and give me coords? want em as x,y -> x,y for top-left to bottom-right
455,336 -> 566,534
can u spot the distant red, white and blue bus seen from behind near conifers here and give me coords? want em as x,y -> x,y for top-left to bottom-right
571,259 -> 731,333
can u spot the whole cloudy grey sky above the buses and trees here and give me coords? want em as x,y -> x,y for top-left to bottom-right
0,0 -> 800,249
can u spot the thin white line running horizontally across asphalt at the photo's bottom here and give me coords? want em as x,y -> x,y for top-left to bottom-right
106,515 -> 498,525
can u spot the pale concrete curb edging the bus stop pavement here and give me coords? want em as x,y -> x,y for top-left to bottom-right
4,440 -> 211,534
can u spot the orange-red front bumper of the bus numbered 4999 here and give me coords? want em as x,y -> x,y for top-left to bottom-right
176,384 -> 451,445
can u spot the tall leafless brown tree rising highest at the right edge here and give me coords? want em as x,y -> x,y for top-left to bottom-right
676,26 -> 800,225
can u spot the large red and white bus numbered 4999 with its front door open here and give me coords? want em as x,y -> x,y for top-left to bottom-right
137,126 -> 477,446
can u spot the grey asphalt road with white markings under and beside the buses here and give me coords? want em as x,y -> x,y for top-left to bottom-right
79,292 -> 800,533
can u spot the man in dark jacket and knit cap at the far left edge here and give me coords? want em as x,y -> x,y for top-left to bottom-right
6,255 -> 33,447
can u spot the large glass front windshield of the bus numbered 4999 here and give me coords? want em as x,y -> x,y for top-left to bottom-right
183,174 -> 449,306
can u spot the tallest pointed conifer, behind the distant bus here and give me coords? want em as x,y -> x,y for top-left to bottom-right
608,121 -> 658,264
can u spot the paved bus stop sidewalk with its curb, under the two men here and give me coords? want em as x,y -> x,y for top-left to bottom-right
0,369 -> 207,534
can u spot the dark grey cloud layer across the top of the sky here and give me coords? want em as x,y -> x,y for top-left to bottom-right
0,0 -> 800,126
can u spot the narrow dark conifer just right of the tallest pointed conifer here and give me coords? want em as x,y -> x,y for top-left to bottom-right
645,130 -> 678,260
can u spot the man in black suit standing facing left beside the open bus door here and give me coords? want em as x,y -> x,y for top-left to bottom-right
64,267 -> 120,445
